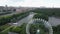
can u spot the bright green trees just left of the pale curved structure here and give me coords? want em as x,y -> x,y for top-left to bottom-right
10,24 -> 26,34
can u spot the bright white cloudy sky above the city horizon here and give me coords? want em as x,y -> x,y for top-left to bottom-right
0,0 -> 60,7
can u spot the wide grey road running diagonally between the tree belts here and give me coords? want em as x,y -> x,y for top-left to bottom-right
10,13 -> 35,26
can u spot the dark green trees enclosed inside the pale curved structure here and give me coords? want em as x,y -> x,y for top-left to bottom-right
30,23 -> 48,34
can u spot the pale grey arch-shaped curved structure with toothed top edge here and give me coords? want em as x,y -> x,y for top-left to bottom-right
26,18 -> 53,34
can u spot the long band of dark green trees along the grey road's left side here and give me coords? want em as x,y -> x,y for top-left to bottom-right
0,12 -> 29,25
